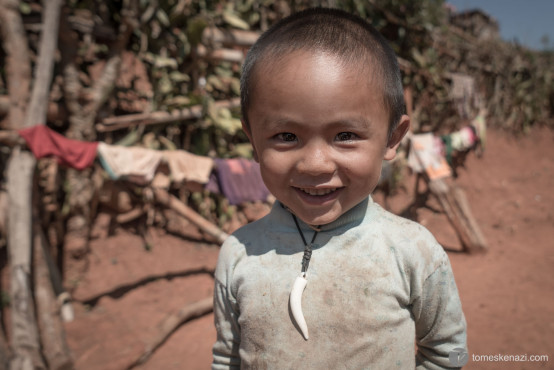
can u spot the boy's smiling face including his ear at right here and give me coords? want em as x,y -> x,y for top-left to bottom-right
245,51 -> 409,225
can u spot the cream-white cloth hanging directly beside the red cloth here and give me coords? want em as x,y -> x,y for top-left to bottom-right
98,143 -> 163,183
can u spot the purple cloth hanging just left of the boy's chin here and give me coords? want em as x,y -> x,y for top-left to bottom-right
206,158 -> 270,204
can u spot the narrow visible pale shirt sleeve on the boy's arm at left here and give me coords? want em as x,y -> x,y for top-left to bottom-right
212,258 -> 240,370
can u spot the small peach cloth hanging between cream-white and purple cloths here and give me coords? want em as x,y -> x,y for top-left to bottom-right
163,150 -> 214,184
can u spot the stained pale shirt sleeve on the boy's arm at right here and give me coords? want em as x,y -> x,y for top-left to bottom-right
412,253 -> 467,369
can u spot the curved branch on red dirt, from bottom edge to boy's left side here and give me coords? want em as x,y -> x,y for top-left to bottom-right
127,297 -> 213,370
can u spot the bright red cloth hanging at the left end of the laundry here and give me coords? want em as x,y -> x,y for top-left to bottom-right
18,125 -> 98,170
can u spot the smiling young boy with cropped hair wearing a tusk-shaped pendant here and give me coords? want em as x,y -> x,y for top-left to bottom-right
212,9 -> 466,369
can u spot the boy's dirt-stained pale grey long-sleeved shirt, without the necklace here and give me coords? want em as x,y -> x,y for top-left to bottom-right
212,198 -> 466,369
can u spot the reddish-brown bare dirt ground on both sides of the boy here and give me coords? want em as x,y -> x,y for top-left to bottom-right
65,128 -> 554,370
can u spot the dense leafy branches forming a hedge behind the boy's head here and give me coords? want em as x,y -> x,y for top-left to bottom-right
0,0 -> 554,147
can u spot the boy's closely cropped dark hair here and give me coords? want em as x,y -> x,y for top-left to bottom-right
240,8 -> 406,138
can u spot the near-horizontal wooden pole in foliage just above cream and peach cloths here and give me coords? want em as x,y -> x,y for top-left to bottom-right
96,98 -> 240,132
